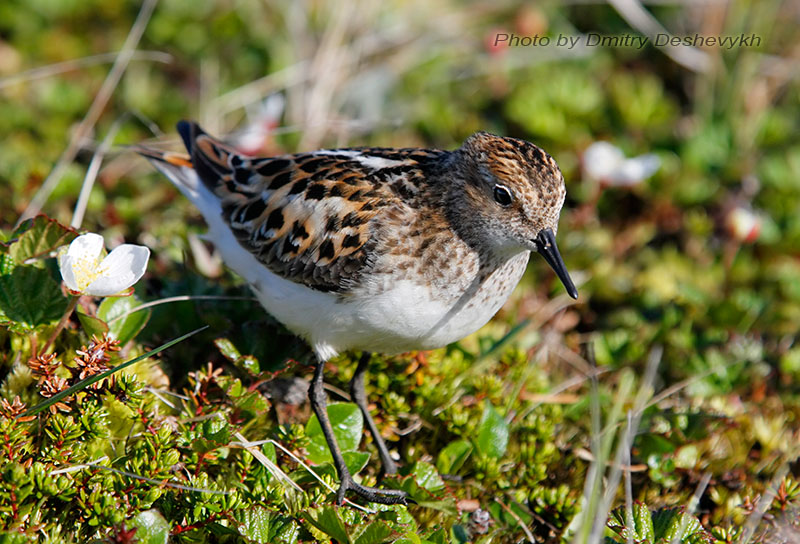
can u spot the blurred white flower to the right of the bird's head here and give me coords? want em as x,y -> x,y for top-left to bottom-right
583,142 -> 661,187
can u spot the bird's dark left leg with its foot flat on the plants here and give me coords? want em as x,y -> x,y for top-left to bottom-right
308,361 -> 409,505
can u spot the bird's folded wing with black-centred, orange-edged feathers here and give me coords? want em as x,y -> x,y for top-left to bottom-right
148,122 -> 446,292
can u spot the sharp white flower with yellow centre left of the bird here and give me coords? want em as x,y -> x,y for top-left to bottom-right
59,232 -> 150,297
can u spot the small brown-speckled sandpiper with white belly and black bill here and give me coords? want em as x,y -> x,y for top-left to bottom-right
136,121 -> 578,505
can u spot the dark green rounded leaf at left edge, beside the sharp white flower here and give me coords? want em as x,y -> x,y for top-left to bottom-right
0,266 -> 67,329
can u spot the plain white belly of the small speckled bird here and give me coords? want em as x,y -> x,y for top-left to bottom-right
245,251 -> 528,360
